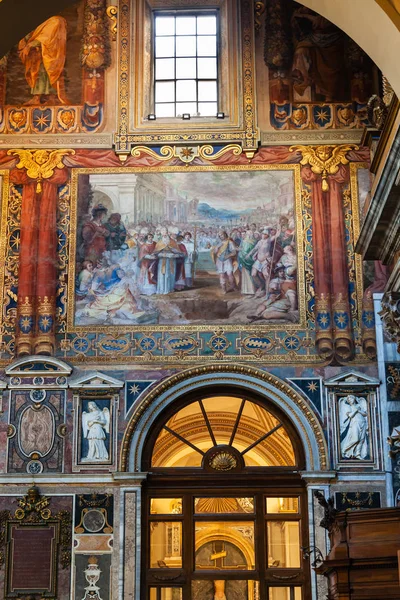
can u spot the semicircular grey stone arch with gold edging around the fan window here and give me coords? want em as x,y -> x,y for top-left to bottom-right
121,364 -> 329,472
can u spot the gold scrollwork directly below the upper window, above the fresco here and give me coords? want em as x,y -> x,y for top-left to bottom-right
131,144 -> 243,164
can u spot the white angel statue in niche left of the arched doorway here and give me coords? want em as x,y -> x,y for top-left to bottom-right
82,402 -> 110,462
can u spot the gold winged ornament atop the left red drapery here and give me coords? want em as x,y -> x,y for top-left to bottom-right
7,149 -> 75,194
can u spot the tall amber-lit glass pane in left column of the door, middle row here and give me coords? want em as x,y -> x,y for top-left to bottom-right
150,521 -> 182,569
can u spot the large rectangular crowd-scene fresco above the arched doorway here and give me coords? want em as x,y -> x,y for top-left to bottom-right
75,168 -> 299,326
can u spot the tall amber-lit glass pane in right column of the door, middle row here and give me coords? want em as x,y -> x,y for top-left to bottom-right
267,521 -> 300,569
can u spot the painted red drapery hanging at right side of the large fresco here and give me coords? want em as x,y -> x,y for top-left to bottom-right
301,165 -> 353,361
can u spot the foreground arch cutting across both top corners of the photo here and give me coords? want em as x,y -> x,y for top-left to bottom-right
0,0 -> 400,97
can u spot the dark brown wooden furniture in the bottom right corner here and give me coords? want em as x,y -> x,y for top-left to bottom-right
316,508 -> 400,600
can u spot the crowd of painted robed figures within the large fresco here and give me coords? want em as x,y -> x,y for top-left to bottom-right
76,204 -> 298,323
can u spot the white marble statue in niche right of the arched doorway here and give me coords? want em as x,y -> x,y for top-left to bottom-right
339,394 -> 369,460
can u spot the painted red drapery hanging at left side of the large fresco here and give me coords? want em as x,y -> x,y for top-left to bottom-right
10,169 -> 68,356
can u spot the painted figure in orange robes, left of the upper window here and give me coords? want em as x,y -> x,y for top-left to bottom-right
18,16 -> 68,105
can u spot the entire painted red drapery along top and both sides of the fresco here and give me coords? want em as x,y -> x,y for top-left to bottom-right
0,146 -> 369,361
